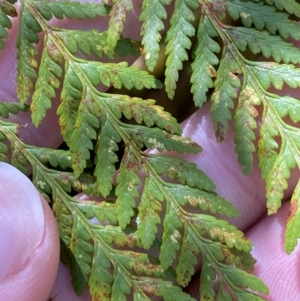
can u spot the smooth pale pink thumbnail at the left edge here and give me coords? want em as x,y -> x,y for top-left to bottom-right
0,162 -> 44,282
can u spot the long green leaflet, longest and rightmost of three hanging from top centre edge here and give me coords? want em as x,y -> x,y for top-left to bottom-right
165,0 -> 199,99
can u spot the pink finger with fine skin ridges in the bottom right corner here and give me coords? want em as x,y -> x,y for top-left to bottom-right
246,203 -> 300,301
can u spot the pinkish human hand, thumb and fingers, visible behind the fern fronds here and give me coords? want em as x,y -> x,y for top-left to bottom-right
0,1 -> 299,301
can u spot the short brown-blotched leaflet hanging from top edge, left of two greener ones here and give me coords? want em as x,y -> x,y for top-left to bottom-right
107,0 -> 133,50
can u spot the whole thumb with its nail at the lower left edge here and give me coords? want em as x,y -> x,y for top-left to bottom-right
0,162 -> 59,301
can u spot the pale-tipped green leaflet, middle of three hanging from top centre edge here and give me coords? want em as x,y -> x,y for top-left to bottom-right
139,0 -> 172,71
